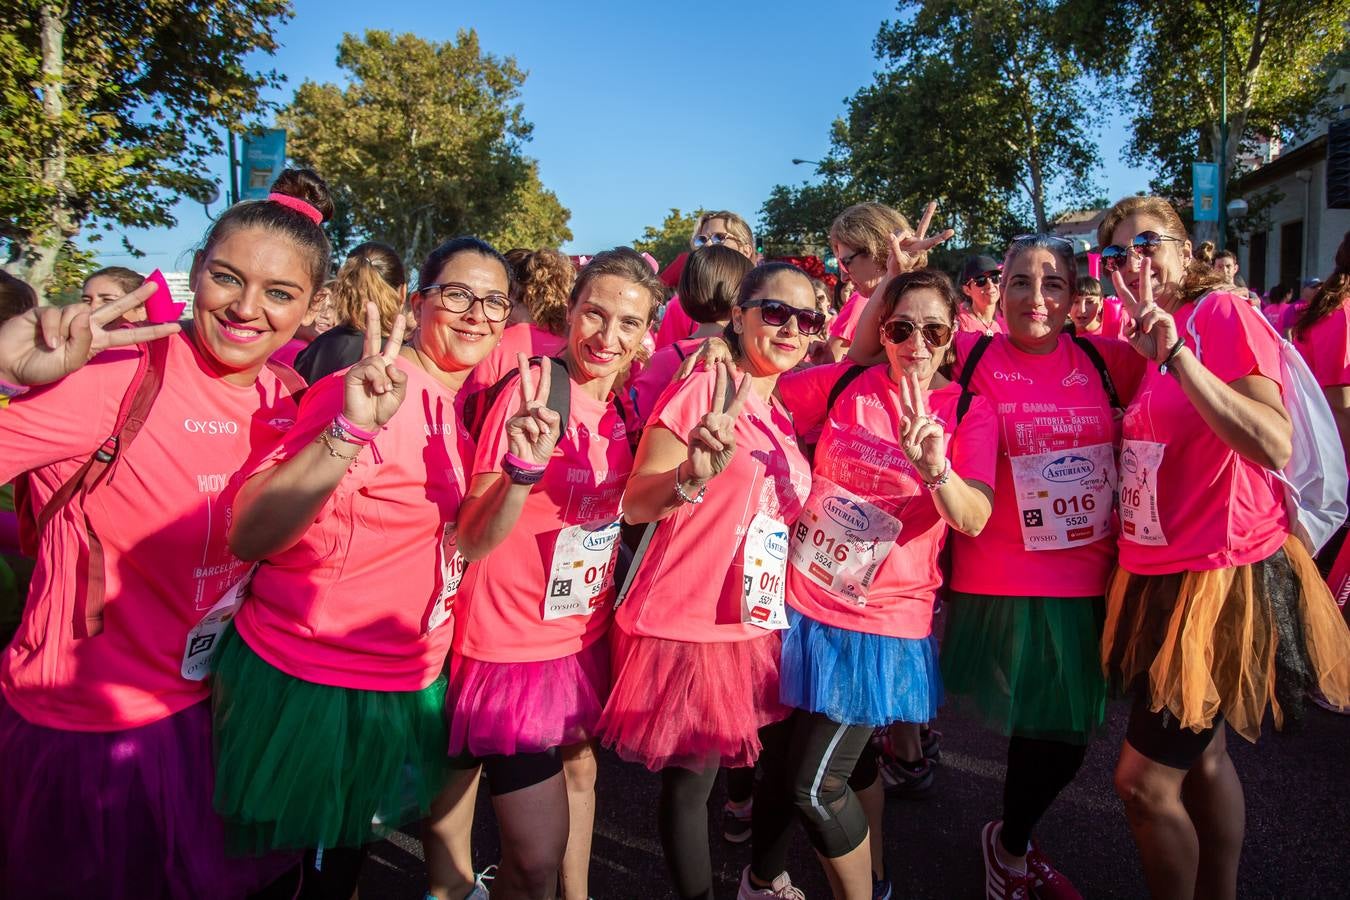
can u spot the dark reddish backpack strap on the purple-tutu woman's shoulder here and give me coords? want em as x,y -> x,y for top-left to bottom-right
36,337 -> 170,638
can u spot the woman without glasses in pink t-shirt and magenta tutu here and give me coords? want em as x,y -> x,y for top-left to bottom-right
441,247 -> 664,900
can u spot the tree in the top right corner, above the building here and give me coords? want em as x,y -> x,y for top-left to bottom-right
1123,0 -> 1350,237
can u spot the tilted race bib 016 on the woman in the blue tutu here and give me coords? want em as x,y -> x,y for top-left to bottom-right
788,475 -> 900,606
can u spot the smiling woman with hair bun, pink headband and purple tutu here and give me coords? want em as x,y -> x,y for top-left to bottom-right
0,170 -> 332,900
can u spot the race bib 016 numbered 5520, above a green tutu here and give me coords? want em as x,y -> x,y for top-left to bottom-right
1011,444 -> 1116,551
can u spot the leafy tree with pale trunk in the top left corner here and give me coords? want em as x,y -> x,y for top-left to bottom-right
0,0 -> 290,297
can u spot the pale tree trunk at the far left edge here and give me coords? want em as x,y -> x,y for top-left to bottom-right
17,3 -> 80,302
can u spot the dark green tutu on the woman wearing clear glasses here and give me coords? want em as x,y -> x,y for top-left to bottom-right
212,627 -> 450,854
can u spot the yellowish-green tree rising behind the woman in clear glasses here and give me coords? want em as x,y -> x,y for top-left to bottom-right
287,31 -> 571,271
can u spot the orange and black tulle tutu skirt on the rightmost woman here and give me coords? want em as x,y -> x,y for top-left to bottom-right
1102,537 -> 1350,741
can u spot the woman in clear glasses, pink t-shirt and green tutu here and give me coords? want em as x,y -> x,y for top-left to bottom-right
213,237 -> 510,896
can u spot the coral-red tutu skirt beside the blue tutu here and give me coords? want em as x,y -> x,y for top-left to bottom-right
599,627 -> 792,772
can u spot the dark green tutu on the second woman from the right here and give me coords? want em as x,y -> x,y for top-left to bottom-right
941,592 -> 1106,745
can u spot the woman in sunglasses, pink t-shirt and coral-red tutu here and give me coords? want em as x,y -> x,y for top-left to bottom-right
601,263 -> 825,897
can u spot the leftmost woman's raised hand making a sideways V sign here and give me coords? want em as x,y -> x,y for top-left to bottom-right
0,282 -> 181,386
